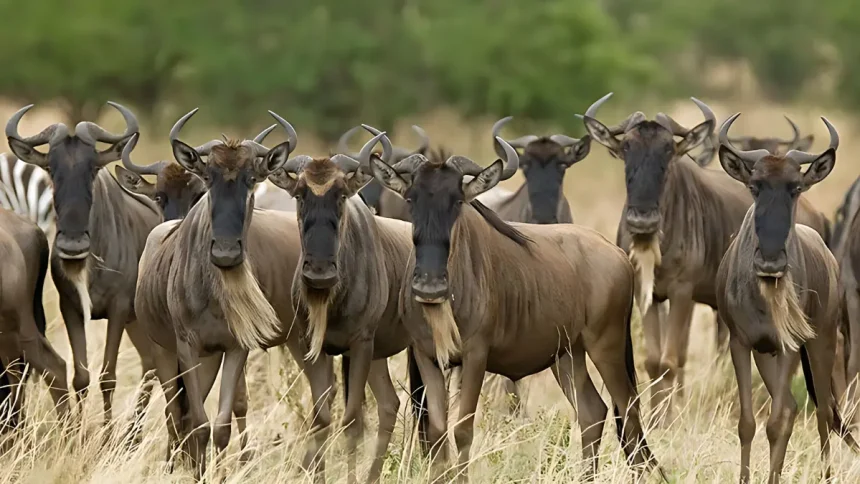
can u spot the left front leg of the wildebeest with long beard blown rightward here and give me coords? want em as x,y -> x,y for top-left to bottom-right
176,338 -> 209,479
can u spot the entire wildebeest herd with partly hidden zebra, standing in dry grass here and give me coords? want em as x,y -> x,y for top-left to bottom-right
0,93 -> 860,482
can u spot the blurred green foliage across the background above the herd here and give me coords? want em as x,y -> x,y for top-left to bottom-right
0,0 -> 848,138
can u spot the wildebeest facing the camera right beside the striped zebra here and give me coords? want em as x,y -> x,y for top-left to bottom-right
6,102 -> 161,421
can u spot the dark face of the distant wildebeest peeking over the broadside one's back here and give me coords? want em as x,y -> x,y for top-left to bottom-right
520,137 -> 591,224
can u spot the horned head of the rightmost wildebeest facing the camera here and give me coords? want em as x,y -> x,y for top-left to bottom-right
720,114 -> 839,278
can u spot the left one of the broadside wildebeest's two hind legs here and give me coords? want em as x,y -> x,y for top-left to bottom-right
552,346 -> 606,481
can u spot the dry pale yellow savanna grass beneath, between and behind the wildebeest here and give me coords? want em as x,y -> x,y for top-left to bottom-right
0,97 -> 860,484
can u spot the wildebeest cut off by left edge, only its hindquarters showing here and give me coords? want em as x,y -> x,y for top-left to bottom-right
0,208 -> 69,427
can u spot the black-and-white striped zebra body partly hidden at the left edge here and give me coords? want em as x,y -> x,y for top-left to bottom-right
0,153 -> 54,233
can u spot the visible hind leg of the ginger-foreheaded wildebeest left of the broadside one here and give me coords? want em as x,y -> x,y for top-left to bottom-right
367,359 -> 400,482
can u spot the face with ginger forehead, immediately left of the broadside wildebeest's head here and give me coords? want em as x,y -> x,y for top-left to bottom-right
269,155 -> 371,289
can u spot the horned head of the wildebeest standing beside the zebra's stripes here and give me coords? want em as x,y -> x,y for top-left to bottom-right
6,102 -> 138,260
